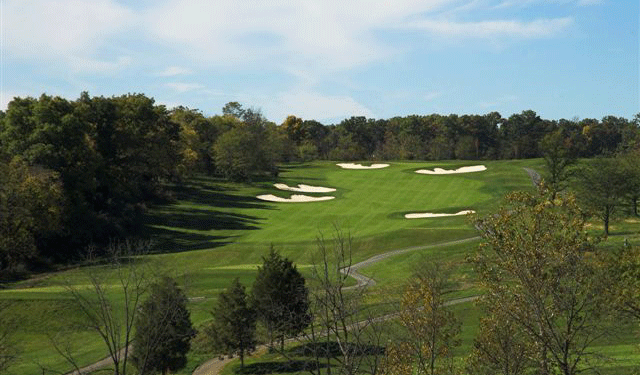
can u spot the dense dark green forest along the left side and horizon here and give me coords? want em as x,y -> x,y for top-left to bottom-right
0,93 -> 640,280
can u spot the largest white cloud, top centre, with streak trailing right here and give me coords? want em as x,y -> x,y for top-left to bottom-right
142,0 -> 576,84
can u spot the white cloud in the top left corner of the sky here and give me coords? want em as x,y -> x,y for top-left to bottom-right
2,0 -> 134,57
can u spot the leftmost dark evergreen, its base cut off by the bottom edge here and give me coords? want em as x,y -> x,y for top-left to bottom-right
133,277 -> 195,374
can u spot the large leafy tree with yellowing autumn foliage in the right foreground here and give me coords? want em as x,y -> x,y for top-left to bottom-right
473,192 -> 609,375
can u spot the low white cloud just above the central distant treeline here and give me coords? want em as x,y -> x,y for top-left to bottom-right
263,90 -> 374,122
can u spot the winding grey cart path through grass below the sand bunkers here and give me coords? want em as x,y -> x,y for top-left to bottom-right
193,236 -> 480,375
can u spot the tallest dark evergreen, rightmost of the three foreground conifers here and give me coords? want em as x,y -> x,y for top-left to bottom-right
253,247 -> 311,349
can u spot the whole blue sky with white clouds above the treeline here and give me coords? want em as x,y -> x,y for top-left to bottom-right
0,0 -> 640,124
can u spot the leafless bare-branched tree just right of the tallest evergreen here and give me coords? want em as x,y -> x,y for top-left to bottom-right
300,229 -> 384,375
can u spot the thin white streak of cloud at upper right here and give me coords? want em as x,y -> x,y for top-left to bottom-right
407,17 -> 573,39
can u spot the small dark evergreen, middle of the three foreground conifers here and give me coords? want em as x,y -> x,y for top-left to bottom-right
208,278 -> 256,367
